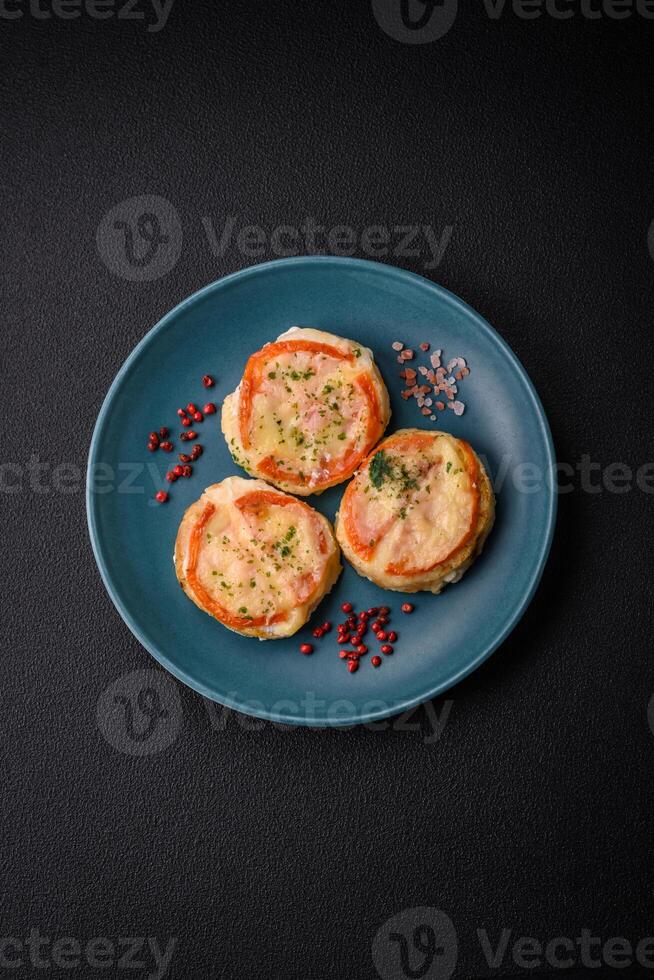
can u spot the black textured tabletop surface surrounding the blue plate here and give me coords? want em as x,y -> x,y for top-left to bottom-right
0,0 -> 654,980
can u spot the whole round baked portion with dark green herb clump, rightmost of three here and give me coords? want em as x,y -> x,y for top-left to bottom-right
336,429 -> 495,592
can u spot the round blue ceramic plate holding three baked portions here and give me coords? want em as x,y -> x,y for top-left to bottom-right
87,257 -> 556,726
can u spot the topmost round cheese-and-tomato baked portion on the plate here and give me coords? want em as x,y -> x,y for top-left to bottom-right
222,327 -> 391,496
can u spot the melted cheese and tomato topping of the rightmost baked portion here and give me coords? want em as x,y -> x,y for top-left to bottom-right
346,433 -> 478,576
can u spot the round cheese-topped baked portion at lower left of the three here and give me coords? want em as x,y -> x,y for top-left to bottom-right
174,476 -> 341,640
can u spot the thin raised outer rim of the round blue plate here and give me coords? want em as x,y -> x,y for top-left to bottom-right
85,255 -> 558,728
